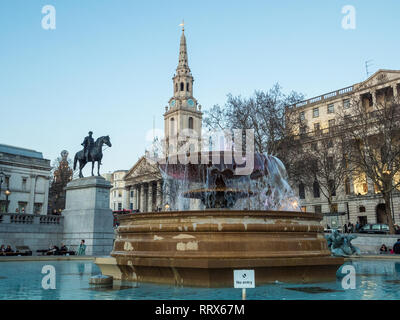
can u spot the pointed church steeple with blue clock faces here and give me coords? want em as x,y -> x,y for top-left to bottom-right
164,23 -> 203,154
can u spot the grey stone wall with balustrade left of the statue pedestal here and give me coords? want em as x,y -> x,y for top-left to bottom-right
0,213 -> 63,255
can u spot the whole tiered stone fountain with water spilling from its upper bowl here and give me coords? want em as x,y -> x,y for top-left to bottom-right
96,151 -> 343,287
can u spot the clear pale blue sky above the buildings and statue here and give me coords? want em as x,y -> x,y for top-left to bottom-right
0,0 -> 400,174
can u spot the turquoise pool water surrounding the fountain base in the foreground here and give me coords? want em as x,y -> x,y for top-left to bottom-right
0,260 -> 400,300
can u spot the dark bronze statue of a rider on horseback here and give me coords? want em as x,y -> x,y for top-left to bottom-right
74,131 -> 111,178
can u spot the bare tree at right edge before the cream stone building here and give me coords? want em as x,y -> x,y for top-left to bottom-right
340,88 -> 400,234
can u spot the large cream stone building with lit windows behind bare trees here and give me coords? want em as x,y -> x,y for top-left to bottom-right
290,70 -> 400,225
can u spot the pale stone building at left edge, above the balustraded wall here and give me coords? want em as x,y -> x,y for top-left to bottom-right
0,144 -> 51,215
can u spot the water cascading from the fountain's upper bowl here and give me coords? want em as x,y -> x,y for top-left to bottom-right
160,154 -> 300,211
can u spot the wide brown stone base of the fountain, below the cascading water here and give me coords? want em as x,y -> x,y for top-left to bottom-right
96,209 -> 343,287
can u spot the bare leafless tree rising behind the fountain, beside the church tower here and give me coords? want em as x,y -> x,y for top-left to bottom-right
204,84 -> 304,166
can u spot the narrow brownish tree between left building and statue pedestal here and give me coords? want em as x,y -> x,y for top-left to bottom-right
48,150 -> 74,214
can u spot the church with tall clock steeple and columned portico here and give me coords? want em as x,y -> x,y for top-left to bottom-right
123,28 -> 203,212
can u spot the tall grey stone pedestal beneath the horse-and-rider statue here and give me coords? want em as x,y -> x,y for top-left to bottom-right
63,176 -> 114,256
